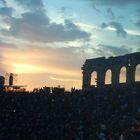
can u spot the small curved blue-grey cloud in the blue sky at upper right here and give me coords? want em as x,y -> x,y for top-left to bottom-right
101,22 -> 127,37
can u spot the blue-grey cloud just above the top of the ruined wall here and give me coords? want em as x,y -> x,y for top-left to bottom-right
97,44 -> 132,56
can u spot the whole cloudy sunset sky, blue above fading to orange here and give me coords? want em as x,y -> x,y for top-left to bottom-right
0,0 -> 140,90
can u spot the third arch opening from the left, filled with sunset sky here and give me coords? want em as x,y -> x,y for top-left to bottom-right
119,66 -> 127,83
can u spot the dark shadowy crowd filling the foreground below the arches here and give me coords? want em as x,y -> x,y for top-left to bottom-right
0,89 -> 140,140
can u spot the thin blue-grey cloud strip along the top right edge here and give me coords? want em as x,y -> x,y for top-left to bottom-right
89,0 -> 140,6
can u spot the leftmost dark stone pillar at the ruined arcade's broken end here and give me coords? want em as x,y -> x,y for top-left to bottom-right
82,71 -> 91,89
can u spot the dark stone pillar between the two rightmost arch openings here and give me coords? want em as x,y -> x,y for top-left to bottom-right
126,65 -> 136,85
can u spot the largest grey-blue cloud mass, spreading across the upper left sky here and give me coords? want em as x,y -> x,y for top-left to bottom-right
0,0 -> 90,42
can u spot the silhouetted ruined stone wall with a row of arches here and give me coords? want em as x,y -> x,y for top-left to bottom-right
82,52 -> 140,89
